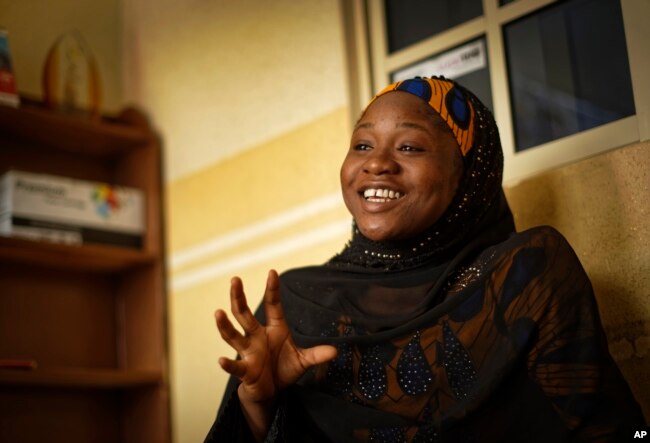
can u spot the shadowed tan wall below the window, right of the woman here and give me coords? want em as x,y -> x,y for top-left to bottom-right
505,142 -> 650,419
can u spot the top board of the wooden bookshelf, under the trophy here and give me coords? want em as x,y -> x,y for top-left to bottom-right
0,104 -> 152,156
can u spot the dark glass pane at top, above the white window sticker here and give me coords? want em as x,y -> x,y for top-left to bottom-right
384,0 -> 483,53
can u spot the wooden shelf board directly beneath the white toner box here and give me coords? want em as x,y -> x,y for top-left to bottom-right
0,236 -> 156,272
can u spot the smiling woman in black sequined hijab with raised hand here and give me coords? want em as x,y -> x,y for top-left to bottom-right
206,77 -> 644,442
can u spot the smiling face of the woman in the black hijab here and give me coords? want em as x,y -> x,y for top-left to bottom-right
341,91 -> 463,241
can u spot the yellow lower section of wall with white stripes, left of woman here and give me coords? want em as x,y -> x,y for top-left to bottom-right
168,109 -> 350,442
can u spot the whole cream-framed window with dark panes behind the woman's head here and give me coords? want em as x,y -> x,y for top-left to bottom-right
341,0 -> 650,182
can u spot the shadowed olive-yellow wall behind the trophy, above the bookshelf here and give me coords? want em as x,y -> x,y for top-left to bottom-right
0,0 -> 123,112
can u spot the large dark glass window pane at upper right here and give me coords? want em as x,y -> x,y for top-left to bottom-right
503,0 -> 635,151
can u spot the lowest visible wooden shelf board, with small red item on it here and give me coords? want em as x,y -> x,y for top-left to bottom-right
0,368 -> 163,389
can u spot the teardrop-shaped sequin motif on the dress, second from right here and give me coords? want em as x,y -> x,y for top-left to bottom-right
397,331 -> 433,396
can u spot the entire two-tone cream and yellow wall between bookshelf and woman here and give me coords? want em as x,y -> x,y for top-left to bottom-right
123,0 -> 350,442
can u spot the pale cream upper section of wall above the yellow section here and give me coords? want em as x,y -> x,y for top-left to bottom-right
123,0 -> 347,182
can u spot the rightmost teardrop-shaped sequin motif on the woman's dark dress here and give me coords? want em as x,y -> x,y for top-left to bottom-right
442,322 -> 477,400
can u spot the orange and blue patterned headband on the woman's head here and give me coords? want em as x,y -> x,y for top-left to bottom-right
370,77 -> 474,157
